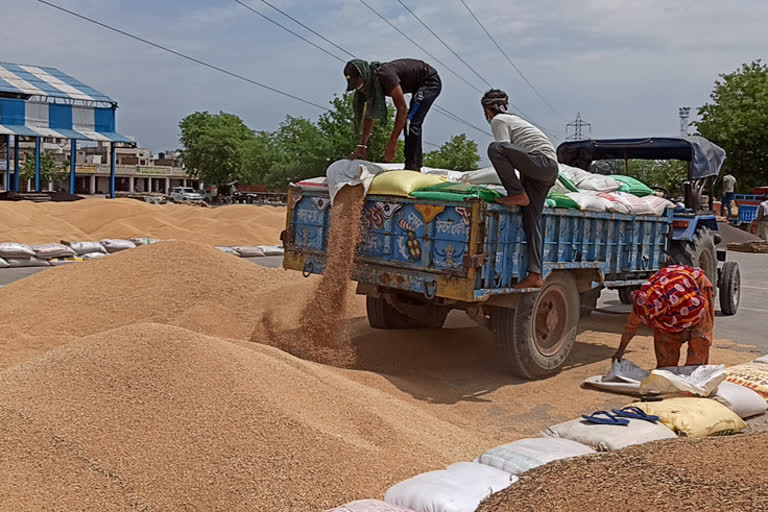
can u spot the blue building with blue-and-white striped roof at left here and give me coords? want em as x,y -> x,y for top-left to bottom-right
0,62 -> 135,197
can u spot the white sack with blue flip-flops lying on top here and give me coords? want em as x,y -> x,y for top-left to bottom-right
544,418 -> 677,452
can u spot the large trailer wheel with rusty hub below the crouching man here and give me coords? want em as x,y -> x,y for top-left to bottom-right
491,272 -> 579,380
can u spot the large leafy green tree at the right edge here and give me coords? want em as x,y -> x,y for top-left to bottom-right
696,60 -> 768,189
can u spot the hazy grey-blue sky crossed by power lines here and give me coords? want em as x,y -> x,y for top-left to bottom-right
0,0 -> 768,160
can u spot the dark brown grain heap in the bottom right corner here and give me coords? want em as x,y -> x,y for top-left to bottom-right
478,434 -> 768,512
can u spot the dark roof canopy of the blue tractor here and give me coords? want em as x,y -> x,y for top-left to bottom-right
557,137 -> 725,179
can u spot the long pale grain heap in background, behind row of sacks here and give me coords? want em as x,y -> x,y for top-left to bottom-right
0,199 -> 285,245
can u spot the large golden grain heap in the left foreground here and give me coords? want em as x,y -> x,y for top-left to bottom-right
0,324 -> 482,512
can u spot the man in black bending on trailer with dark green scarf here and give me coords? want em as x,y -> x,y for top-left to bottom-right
344,59 -> 442,171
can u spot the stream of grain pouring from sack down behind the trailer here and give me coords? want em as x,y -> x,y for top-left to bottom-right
262,185 -> 365,366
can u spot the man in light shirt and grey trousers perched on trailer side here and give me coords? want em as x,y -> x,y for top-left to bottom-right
480,89 -> 559,289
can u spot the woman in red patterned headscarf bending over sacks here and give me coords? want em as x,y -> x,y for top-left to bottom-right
613,265 -> 715,368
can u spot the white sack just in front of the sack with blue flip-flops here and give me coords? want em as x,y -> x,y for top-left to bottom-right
475,437 -> 595,475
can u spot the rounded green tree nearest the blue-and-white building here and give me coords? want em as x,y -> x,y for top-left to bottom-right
179,112 -> 254,185
